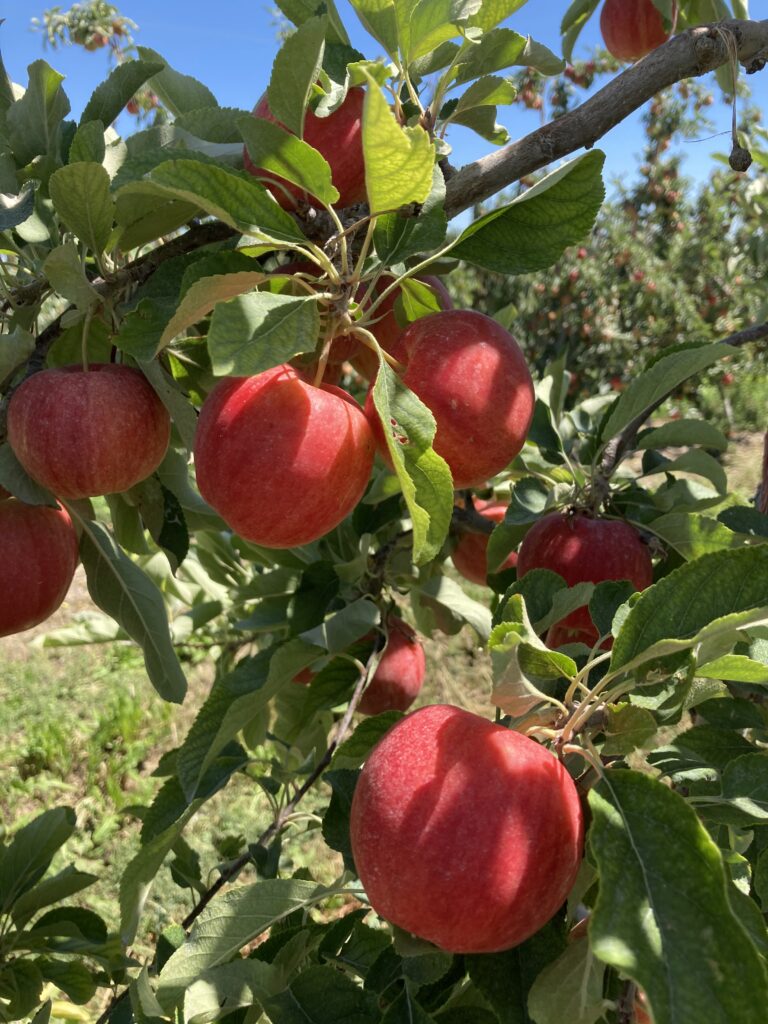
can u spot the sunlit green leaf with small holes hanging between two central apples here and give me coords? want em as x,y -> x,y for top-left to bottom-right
373,359 -> 454,565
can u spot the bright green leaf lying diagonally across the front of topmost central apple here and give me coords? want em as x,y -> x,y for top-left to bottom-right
238,117 -> 339,206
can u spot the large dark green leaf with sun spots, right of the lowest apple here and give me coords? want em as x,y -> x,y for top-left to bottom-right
589,770 -> 768,1024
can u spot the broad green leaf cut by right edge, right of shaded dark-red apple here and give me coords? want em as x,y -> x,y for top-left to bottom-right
610,545 -> 768,673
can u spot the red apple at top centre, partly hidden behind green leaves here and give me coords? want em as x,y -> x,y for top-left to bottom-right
243,86 -> 366,210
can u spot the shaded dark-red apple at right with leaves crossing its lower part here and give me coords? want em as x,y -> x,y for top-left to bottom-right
517,511 -> 653,647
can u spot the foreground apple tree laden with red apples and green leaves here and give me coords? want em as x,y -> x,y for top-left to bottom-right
0,0 -> 768,1024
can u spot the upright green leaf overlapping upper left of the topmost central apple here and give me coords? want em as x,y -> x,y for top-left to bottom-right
268,17 -> 325,135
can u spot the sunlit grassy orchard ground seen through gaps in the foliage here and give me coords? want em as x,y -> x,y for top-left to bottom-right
0,432 -> 763,958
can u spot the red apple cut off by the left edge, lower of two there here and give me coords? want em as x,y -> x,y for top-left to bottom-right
0,498 -> 78,637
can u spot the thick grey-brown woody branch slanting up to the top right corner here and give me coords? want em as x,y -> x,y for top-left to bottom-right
445,19 -> 768,217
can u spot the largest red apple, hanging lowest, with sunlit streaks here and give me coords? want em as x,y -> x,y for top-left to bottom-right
350,705 -> 584,953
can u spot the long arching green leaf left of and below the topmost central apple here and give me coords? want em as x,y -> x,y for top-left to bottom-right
118,159 -> 306,243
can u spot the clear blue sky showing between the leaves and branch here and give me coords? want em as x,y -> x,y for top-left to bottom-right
0,0 -> 768,203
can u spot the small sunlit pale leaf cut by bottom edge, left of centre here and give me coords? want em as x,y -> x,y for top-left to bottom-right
184,959 -> 285,1024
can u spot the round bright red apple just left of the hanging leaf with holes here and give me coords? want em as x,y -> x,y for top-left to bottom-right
195,365 -> 375,548
